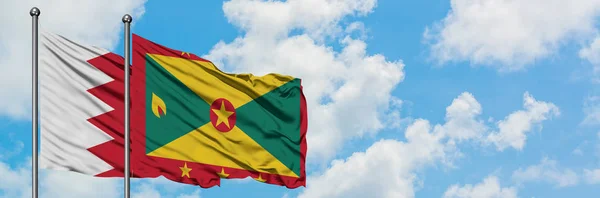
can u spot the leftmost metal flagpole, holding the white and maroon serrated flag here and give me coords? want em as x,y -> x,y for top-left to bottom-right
29,7 -> 40,198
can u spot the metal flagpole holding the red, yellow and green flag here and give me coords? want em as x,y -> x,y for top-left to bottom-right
123,14 -> 132,198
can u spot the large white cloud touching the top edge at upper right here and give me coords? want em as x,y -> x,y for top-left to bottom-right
424,0 -> 600,71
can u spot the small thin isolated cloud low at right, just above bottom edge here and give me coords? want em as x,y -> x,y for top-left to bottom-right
512,158 -> 579,187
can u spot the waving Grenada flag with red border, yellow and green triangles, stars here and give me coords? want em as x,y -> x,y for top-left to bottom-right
126,34 -> 307,188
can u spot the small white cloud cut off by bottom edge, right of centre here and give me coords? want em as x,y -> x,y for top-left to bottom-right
444,176 -> 517,198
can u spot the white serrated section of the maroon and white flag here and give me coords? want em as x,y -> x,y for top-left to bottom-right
39,31 -> 113,175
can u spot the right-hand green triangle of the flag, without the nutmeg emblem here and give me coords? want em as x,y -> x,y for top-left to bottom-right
236,79 -> 302,175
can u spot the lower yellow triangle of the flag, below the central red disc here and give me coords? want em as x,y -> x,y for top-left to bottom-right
148,122 -> 298,177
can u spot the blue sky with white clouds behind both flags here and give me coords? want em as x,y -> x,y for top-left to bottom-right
0,0 -> 600,198
